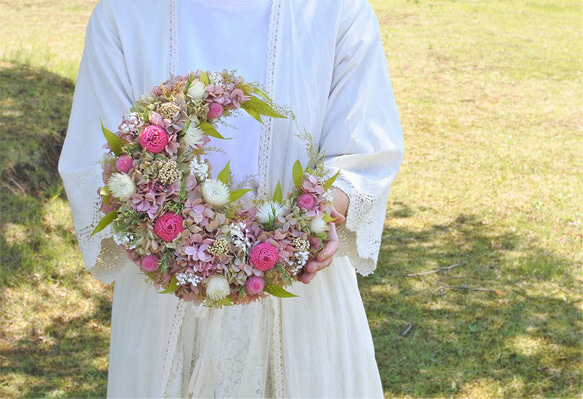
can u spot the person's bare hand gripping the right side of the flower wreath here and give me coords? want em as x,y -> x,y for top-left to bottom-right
299,189 -> 348,284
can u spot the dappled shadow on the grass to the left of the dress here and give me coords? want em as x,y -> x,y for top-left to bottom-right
0,63 -> 111,397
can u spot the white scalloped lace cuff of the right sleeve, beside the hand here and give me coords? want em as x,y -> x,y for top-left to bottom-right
334,172 -> 385,276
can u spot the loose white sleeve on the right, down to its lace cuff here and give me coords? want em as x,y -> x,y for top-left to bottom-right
320,0 -> 403,275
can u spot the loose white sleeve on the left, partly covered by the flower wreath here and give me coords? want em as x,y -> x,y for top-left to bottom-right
59,2 -> 132,283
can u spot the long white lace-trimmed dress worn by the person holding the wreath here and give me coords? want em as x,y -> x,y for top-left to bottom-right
59,0 -> 402,398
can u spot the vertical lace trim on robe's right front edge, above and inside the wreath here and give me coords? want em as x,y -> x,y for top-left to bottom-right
258,0 -> 281,197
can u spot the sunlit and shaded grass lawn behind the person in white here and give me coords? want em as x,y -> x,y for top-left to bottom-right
0,0 -> 583,398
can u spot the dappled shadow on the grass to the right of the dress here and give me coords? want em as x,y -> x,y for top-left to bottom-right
359,204 -> 583,398
